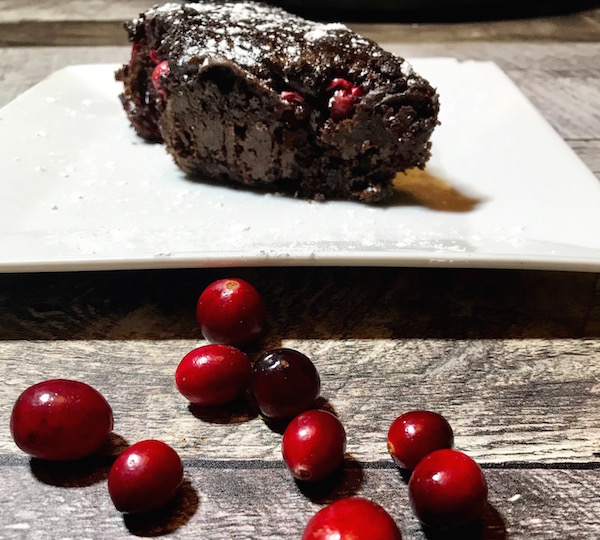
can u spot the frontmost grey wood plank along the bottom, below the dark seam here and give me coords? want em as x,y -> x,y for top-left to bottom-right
0,462 -> 600,540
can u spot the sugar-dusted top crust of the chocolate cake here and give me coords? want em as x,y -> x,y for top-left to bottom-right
127,0 -> 419,92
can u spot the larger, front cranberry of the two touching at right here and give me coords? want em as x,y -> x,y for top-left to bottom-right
408,449 -> 488,529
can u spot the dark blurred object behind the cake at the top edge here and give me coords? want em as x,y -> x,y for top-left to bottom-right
268,0 -> 600,22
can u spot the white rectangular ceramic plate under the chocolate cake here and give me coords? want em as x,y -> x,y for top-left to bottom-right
0,58 -> 600,272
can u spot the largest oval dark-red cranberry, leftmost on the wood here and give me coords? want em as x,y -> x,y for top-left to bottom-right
10,379 -> 113,461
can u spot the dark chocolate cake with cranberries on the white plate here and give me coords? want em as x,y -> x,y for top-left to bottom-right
116,0 -> 439,202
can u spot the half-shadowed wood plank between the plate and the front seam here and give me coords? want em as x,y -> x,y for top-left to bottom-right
0,268 -> 600,463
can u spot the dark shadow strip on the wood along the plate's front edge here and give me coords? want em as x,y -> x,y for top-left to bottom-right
0,267 -> 600,340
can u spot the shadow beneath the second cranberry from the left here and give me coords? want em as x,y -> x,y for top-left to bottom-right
123,480 -> 200,537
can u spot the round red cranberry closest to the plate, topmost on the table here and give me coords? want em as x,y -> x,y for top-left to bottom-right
196,278 -> 266,347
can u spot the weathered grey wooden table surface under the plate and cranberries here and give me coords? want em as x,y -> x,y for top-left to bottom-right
0,0 -> 600,540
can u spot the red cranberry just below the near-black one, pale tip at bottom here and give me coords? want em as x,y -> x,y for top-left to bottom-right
281,410 -> 346,480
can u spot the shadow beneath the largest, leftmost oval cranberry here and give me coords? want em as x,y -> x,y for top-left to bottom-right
29,433 -> 128,488
